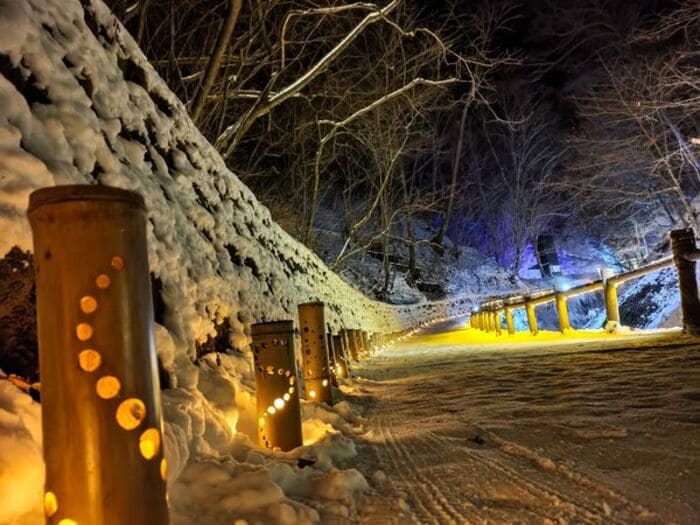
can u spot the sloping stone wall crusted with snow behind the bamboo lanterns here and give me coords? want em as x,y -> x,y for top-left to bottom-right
0,0 -> 470,356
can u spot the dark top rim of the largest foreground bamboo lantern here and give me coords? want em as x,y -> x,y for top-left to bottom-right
27,184 -> 146,213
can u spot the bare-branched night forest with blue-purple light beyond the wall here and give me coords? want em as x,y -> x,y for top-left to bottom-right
108,0 -> 700,286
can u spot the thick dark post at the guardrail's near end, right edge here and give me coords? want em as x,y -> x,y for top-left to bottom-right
670,228 -> 700,335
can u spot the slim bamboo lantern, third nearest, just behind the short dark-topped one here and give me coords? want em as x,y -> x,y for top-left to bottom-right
298,302 -> 333,405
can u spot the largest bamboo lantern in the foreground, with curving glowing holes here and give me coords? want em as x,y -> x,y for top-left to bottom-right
28,186 -> 169,525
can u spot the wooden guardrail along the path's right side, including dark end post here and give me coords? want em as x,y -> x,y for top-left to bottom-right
470,229 -> 700,335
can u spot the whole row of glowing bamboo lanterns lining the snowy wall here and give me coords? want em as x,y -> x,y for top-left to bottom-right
28,186 -> 404,525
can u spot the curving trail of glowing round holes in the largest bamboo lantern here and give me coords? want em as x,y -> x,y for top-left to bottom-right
44,255 -> 168,525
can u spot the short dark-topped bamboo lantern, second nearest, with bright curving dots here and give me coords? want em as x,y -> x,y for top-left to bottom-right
251,321 -> 303,450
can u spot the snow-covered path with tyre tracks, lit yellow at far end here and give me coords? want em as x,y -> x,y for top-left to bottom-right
348,322 -> 700,524
